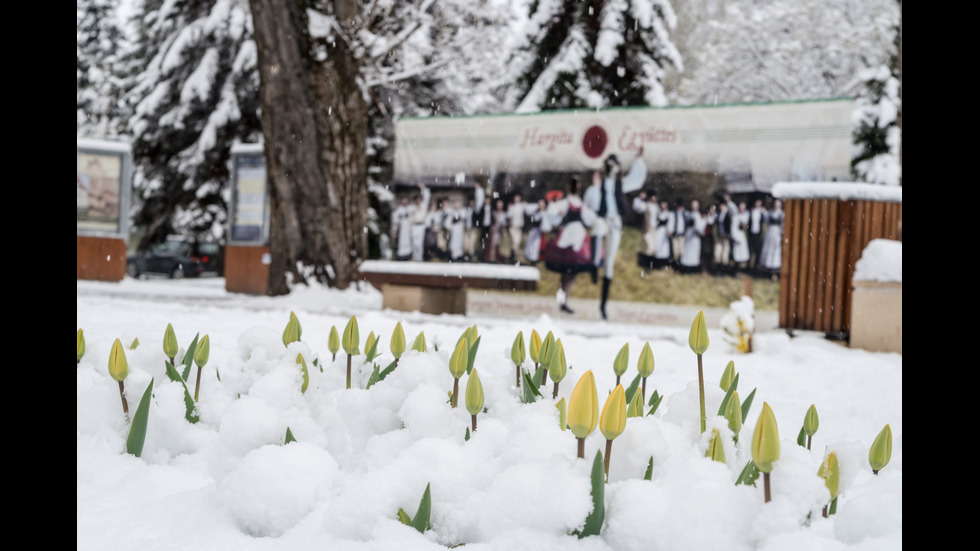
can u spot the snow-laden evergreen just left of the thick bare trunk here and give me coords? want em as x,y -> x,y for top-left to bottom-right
127,0 -> 260,247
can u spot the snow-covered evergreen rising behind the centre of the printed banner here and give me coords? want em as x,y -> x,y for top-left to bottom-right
505,0 -> 683,112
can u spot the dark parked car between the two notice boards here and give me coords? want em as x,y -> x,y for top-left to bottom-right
126,237 -> 224,279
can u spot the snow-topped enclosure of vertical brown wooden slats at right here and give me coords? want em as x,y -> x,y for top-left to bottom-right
773,184 -> 902,336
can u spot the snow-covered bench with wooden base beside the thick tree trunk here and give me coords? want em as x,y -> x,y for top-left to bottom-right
358,260 -> 541,315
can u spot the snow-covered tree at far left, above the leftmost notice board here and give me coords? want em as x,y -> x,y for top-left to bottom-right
75,0 -> 125,138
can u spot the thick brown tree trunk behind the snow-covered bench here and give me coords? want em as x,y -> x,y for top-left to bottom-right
249,0 -> 367,295
